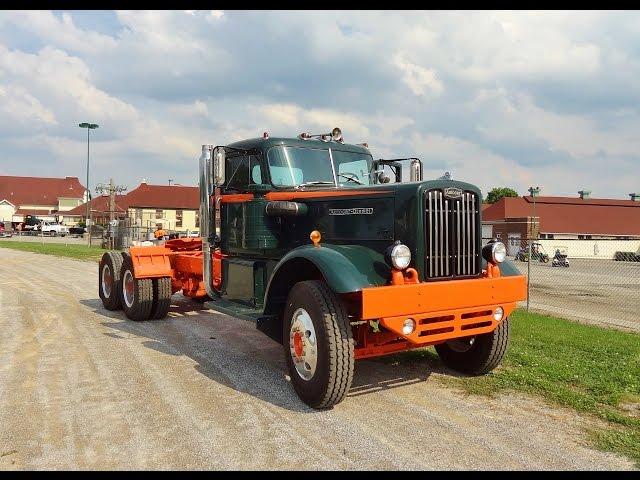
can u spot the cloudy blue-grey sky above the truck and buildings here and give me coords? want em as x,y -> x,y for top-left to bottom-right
0,11 -> 640,198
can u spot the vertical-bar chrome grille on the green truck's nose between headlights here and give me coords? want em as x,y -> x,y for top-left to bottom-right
425,190 -> 480,279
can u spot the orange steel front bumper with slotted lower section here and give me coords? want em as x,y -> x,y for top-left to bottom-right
362,275 -> 527,345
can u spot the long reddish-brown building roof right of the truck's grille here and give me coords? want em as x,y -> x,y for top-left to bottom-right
482,196 -> 640,236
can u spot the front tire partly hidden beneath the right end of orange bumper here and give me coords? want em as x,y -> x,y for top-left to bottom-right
435,318 -> 510,375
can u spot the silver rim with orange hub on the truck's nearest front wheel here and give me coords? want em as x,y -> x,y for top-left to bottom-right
289,308 -> 318,380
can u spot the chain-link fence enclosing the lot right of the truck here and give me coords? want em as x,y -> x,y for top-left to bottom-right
483,236 -> 640,331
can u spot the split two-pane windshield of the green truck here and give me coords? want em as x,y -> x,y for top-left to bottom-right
267,146 -> 373,187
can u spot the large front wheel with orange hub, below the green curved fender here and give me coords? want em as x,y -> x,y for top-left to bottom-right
282,280 -> 354,409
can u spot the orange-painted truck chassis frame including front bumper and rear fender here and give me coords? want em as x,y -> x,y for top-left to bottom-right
129,238 -> 526,359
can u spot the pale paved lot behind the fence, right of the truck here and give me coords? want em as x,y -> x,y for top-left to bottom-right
515,258 -> 640,331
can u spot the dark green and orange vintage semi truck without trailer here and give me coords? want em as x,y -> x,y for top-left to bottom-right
98,128 -> 526,409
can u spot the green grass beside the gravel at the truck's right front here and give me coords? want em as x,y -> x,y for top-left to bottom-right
401,310 -> 640,466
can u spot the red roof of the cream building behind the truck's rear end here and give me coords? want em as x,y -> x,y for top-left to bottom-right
125,182 -> 200,210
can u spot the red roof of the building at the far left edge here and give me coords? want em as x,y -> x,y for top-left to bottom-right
0,175 -> 85,207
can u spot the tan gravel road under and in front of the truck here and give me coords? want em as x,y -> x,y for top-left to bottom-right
0,248 -> 633,470
